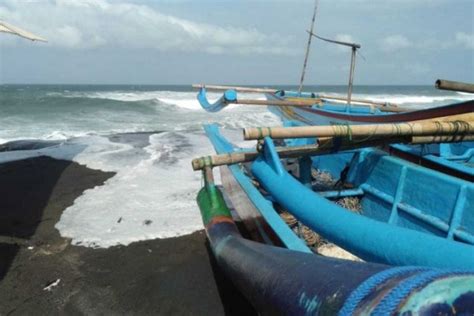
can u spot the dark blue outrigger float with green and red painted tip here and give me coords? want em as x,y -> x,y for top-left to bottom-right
198,172 -> 474,315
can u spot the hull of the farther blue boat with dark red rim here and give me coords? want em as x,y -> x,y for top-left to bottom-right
266,91 -> 474,181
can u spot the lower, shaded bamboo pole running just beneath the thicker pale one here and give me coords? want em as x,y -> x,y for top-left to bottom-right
192,135 -> 474,170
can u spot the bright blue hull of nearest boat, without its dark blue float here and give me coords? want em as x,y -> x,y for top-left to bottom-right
206,126 -> 474,268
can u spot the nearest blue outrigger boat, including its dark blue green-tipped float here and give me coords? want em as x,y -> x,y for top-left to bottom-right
193,122 -> 474,315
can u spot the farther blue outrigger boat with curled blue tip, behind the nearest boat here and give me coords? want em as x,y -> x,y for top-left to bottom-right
194,80 -> 474,181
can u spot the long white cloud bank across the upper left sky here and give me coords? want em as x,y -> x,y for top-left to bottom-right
0,0 -> 295,55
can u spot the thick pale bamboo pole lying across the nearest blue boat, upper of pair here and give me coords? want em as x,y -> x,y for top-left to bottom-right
244,121 -> 474,140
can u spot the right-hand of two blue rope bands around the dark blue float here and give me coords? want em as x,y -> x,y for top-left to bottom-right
372,270 -> 469,316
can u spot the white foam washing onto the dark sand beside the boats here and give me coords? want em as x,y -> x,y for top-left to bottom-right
0,132 -> 240,247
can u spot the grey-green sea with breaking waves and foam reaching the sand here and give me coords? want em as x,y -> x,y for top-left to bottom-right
0,85 -> 473,248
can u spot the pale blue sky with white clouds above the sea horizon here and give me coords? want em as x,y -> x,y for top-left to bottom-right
0,0 -> 474,85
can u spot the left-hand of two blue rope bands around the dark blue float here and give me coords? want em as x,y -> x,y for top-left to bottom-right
339,266 -> 427,316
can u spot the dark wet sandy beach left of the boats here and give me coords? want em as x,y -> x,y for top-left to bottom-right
0,157 -> 254,315
